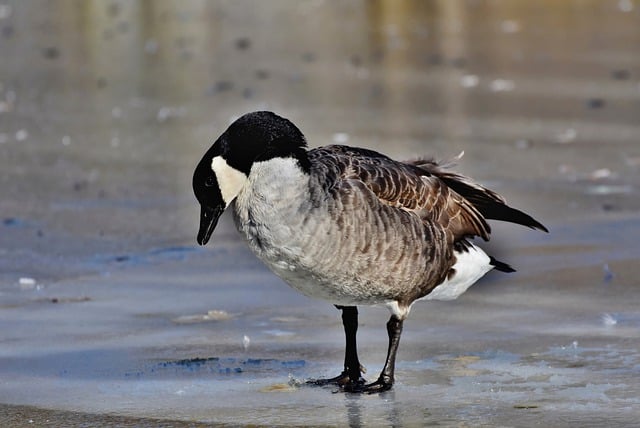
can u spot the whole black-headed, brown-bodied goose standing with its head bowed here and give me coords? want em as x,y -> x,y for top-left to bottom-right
193,111 -> 548,393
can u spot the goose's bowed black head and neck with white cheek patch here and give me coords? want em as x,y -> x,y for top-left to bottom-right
193,111 -> 309,245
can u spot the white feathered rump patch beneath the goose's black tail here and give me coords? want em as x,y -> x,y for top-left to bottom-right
422,245 -> 493,300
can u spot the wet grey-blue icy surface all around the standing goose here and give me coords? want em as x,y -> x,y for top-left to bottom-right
0,0 -> 640,426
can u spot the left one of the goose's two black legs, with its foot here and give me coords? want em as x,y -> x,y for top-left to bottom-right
310,306 -> 365,390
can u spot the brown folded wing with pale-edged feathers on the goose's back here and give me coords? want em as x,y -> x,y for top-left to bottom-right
311,146 -> 491,241
